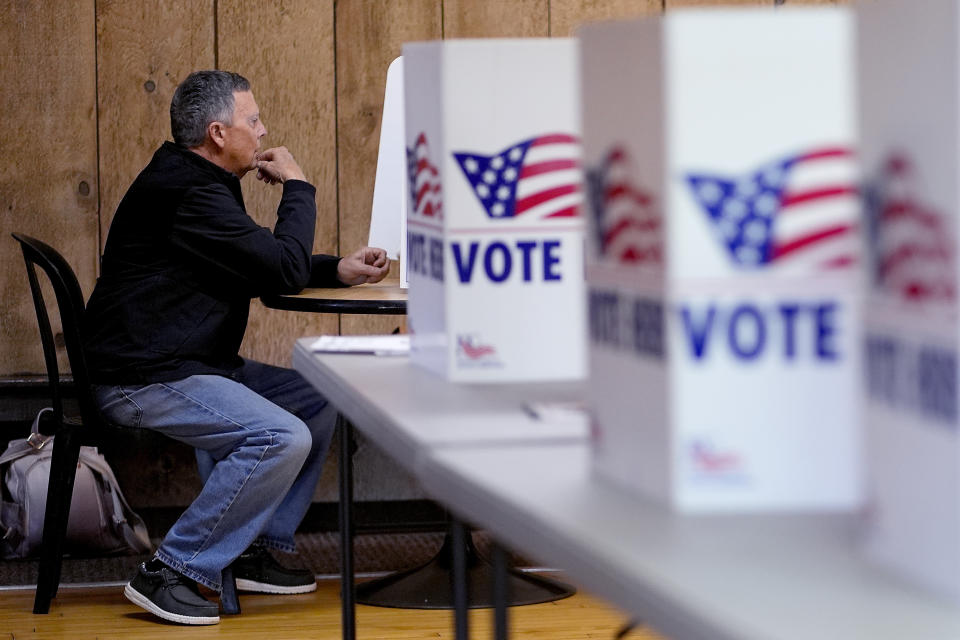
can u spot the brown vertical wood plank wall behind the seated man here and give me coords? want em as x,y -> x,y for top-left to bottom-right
0,0 -> 831,376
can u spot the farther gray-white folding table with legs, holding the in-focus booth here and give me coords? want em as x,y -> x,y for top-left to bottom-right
293,338 -> 588,640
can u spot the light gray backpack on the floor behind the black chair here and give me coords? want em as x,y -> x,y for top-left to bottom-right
0,408 -> 151,558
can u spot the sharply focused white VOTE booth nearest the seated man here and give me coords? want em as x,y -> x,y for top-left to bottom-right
403,39 -> 586,382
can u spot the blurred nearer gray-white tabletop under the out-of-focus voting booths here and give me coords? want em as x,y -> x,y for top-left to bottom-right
419,444 -> 960,640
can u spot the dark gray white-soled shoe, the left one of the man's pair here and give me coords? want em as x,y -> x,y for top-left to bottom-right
123,562 -> 220,624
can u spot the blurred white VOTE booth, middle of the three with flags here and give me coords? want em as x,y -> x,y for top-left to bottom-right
579,8 -> 861,512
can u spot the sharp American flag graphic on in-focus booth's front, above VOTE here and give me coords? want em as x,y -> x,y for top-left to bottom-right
453,133 -> 583,219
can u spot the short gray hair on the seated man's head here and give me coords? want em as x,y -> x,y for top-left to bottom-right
170,70 -> 250,148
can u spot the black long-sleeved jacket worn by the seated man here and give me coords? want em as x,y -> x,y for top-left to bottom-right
83,142 -> 339,384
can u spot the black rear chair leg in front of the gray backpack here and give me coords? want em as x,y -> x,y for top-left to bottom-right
33,429 -> 80,613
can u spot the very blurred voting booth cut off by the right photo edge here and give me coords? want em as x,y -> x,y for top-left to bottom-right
857,0 -> 960,600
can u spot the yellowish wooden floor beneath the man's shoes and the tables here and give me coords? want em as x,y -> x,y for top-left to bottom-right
0,580 -> 661,640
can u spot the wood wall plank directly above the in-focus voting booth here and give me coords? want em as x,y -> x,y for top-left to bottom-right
443,0 -> 550,38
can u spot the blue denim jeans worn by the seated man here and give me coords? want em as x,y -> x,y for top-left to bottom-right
95,360 -> 336,591
